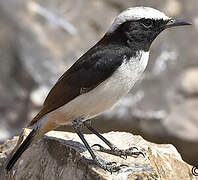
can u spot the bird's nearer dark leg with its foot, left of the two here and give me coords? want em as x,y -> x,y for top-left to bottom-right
72,118 -> 124,173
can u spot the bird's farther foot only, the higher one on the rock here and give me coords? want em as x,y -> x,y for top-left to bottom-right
92,144 -> 145,159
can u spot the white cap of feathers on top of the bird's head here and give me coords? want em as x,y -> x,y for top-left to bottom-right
107,7 -> 171,33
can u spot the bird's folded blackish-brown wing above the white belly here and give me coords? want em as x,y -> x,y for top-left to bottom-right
29,44 -> 123,126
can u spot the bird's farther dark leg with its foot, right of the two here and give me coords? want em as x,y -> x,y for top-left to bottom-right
83,120 -> 144,159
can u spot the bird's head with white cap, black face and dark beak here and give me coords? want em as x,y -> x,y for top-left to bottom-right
106,7 -> 190,51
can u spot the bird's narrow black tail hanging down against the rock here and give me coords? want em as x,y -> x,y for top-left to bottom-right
5,129 -> 37,171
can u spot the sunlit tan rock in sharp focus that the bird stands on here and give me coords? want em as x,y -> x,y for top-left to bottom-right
0,131 -> 198,180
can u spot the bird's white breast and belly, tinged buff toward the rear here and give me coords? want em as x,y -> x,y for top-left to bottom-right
55,52 -> 149,124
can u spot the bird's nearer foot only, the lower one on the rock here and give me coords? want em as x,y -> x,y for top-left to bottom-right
93,157 -> 128,174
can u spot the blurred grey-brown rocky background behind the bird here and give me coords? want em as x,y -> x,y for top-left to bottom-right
0,0 -> 198,165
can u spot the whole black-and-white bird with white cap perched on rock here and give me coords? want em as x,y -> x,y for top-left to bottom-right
5,7 -> 191,172
